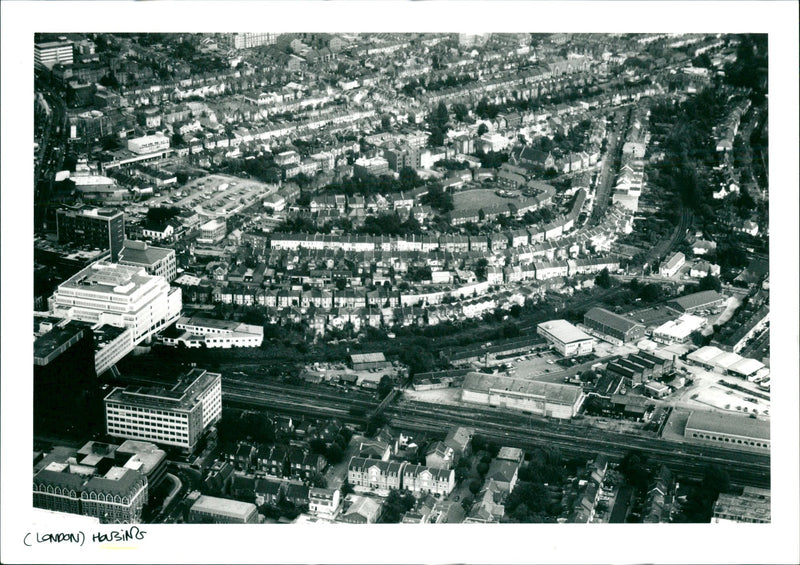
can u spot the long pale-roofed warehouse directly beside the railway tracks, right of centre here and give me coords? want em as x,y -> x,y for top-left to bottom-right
461,373 -> 584,419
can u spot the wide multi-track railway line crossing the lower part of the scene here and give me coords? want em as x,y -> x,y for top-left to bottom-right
108,368 -> 770,487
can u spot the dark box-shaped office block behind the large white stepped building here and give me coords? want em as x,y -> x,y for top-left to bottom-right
56,206 -> 125,262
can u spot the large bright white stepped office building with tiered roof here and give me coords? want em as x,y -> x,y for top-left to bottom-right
49,261 -> 181,345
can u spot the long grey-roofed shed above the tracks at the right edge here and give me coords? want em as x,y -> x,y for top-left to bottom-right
684,410 -> 770,452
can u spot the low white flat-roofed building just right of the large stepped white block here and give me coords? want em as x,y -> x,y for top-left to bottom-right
161,316 -> 264,349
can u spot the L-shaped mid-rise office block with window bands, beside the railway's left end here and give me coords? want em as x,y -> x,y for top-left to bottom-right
105,369 -> 222,452
